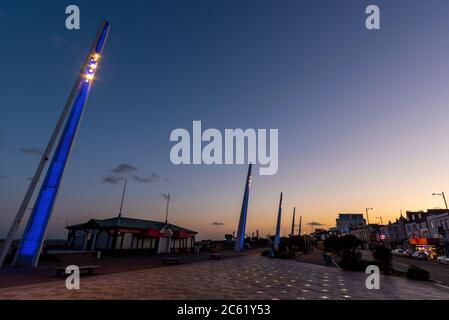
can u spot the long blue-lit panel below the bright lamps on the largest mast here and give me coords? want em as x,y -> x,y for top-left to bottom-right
20,82 -> 89,256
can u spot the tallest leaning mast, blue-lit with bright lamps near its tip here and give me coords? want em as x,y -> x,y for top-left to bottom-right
10,22 -> 110,267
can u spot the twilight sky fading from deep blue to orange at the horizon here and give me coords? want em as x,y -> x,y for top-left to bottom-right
0,0 -> 449,239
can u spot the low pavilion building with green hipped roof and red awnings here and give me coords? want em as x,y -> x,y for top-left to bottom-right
66,217 -> 198,254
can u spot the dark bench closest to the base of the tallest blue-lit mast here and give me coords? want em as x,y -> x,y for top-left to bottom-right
53,252 -> 100,277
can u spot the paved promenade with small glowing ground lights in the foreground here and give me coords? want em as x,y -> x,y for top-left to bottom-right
0,255 -> 449,300
